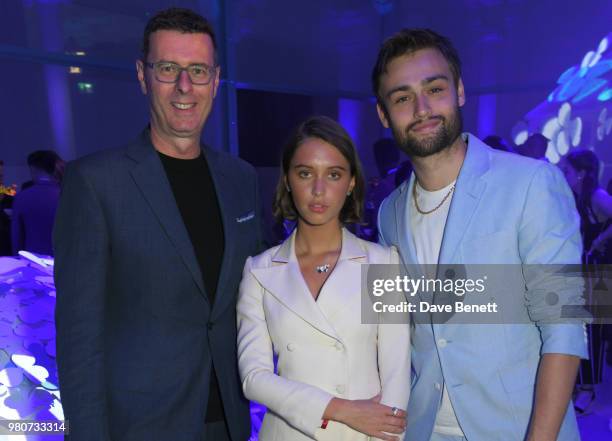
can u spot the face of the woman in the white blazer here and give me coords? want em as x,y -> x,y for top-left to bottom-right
286,138 -> 355,225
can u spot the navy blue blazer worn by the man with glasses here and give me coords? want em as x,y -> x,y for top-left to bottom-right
54,130 -> 262,441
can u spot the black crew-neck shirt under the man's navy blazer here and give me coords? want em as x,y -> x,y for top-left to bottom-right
157,152 -> 225,422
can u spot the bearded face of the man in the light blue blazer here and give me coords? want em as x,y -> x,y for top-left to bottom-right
377,49 -> 465,157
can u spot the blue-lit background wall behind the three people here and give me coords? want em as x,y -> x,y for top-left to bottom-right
0,0 -> 612,183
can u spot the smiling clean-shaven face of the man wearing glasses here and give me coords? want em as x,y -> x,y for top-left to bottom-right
137,30 -> 219,141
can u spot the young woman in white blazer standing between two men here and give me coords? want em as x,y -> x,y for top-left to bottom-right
237,117 -> 410,441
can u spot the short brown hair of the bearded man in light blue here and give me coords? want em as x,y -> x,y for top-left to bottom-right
372,28 -> 461,103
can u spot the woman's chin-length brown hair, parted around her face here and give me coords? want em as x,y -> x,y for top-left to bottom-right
272,116 -> 365,223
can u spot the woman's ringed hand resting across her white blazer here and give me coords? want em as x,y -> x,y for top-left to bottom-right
323,394 -> 406,441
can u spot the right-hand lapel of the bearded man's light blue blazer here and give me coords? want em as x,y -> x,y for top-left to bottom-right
438,135 -> 489,264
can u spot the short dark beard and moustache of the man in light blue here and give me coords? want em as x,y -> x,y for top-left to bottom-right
392,107 -> 463,158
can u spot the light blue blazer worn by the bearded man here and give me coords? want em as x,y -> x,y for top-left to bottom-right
379,134 -> 587,441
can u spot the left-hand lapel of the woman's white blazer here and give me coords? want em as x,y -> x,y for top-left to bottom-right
252,230 -> 338,339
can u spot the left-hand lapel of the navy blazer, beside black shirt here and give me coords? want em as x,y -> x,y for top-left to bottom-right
127,130 -> 208,301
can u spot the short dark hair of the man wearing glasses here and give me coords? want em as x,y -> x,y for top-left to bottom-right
142,8 -> 217,64
